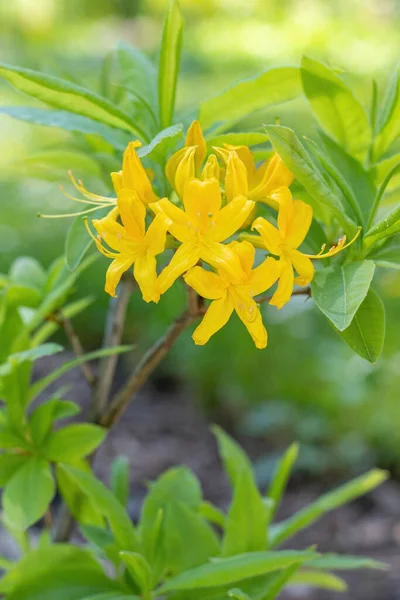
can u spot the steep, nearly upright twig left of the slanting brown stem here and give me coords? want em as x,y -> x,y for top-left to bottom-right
91,277 -> 134,423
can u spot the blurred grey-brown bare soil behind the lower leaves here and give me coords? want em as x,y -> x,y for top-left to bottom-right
0,356 -> 400,600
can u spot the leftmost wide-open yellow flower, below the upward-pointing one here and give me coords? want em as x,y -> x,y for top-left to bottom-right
86,188 -> 170,302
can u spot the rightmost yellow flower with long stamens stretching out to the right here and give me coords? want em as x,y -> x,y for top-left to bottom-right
252,187 -> 360,308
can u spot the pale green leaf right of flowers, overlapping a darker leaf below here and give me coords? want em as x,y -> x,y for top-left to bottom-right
311,260 -> 375,331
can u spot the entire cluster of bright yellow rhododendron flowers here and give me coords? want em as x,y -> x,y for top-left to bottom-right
77,121 -> 353,348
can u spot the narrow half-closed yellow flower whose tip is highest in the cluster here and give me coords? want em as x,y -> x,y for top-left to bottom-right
165,121 -> 207,197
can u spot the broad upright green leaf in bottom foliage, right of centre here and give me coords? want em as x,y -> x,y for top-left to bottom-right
222,469 -> 267,556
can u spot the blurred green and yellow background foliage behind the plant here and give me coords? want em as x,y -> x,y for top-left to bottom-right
0,0 -> 400,474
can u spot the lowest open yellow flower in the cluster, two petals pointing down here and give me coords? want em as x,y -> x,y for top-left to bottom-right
184,242 -> 280,348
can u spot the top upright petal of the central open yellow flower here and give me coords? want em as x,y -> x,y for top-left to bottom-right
183,179 -> 221,232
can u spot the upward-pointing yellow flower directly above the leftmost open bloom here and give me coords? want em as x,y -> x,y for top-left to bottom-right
111,141 -> 158,205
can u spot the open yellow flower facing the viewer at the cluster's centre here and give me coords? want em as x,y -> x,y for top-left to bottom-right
150,179 -> 254,293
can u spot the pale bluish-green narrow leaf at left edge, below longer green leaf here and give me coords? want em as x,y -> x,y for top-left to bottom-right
0,106 -> 129,150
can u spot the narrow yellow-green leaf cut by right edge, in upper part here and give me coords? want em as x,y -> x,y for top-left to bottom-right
374,70 -> 400,159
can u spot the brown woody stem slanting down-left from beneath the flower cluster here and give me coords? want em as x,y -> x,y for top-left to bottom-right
101,310 -> 200,428
